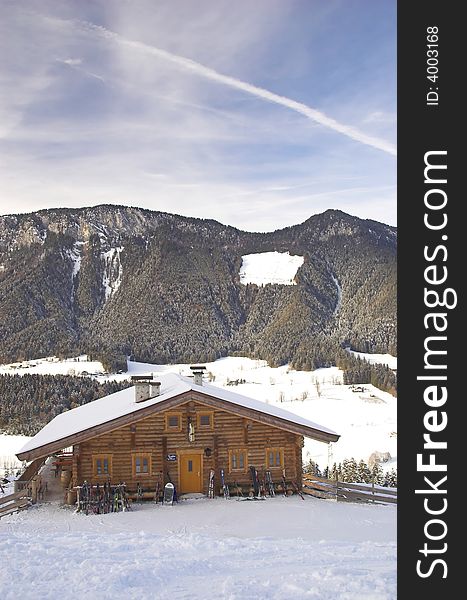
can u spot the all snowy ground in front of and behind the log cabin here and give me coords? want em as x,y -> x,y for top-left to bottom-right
0,357 -> 396,600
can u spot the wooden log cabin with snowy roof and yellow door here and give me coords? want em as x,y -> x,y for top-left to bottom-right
17,372 -> 339,494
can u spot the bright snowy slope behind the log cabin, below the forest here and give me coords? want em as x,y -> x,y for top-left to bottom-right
0,355 -> 397,468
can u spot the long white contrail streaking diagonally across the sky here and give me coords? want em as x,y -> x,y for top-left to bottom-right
80,22 -> 397,156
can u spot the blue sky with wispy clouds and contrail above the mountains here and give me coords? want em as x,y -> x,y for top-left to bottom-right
0,0 -> 396,231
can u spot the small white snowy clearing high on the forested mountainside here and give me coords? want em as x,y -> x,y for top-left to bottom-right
240,252 -> 304,285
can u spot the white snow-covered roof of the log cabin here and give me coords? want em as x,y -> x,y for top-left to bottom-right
17,373 -> 338,455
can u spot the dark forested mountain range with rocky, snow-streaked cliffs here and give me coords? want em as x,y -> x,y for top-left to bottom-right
0,205 -> 397,369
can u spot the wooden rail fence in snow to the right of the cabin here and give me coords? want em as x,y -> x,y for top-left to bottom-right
303,474 -> 397,504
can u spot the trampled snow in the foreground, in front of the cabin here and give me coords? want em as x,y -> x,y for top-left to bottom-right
0,496 -> 396,600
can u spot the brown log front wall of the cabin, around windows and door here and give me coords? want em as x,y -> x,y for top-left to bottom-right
73,397 -> 303,493
